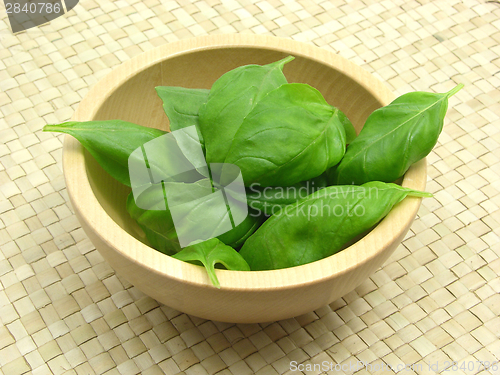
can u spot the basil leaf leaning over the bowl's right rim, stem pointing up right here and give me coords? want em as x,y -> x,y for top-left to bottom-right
332,84 -> 463,185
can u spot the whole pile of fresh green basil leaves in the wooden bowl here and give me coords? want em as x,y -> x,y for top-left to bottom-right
44,56 -> 463,287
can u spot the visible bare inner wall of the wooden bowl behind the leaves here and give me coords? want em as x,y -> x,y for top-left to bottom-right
85,46 -> 382,251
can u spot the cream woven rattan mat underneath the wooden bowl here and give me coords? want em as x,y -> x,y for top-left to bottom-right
0,0 -> 500,375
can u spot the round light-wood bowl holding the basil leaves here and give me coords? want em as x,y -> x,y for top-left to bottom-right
63,35 -> 426,323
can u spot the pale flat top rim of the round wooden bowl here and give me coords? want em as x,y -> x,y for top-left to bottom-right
63,34 -> 426,292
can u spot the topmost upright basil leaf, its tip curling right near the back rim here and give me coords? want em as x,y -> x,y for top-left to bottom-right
199,56 -> 293,164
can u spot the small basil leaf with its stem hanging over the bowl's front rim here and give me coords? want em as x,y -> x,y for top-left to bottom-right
173,238 -> 250,288
